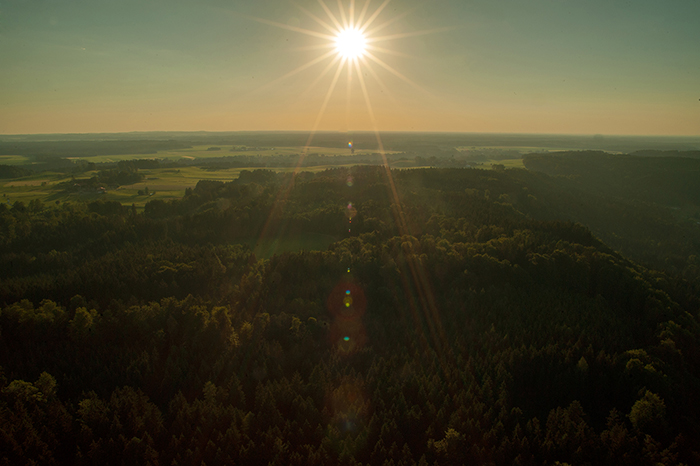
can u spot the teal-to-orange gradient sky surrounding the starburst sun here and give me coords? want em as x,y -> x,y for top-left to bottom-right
0,0 -> 700,135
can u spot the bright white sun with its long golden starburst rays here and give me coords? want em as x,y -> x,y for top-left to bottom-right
253,0 -> 452,378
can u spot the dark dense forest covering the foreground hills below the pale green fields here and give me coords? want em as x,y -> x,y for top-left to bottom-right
0,158 -> 700,466
